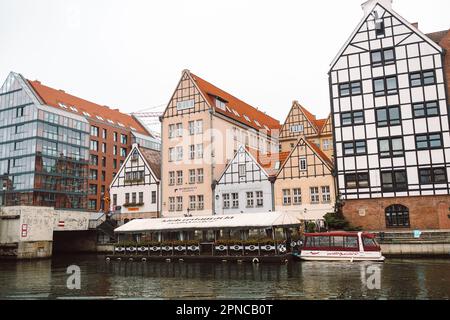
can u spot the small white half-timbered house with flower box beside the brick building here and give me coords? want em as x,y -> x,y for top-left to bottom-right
109,144 -> 161,223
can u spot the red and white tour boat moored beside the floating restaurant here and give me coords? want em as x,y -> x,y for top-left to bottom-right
299,232 -> 385,261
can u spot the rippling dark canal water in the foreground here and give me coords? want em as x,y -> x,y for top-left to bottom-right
0,255 -> 450,299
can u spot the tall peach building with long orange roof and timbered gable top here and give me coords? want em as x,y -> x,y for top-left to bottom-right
161,70 -> 280,216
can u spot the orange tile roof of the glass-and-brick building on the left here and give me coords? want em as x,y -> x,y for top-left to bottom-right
27,80 -> 150,135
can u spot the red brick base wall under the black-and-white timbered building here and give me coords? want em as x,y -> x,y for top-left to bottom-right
343,195 -> 450,230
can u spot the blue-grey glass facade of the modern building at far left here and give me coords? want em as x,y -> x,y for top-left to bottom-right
0,73 -> 89,209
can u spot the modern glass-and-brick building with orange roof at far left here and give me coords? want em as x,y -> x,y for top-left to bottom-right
0,73 -> 160,211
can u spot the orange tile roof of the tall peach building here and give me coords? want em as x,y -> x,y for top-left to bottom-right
190,73 -> 281,135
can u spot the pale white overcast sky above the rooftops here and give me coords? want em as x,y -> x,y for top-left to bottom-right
0,0 -> 450,127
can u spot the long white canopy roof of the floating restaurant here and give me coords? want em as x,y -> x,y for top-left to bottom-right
114,212 -> 301,233
